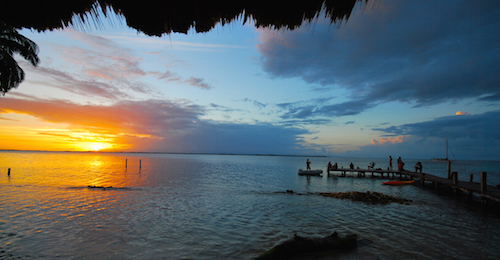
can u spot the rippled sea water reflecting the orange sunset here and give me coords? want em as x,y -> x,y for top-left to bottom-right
0,152 -> 500,259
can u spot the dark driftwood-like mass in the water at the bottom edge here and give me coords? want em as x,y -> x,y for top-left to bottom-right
255,232 -> 357,260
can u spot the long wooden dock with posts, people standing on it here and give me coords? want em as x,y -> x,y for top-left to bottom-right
327,168 -> 500,203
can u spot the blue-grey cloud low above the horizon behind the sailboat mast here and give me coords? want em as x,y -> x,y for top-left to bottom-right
343,110 -> 500,160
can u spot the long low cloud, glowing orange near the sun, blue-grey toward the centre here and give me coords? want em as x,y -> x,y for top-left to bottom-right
0,98 -> 309,154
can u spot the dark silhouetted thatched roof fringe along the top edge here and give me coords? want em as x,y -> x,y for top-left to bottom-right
0,0 -> 370,36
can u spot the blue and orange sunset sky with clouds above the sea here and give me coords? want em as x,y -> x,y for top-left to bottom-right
0,0 -> 500,160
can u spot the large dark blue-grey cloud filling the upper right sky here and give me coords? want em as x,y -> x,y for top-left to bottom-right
258,0 -> 500,118
